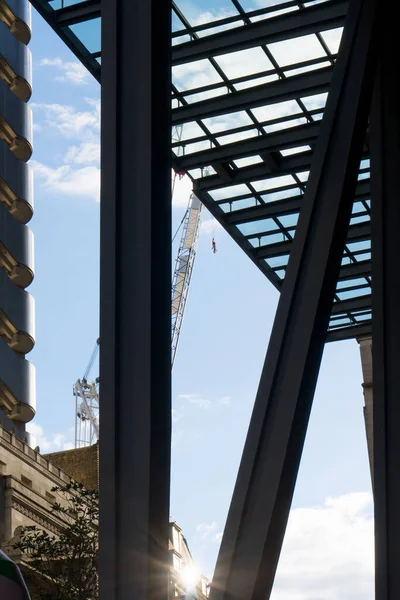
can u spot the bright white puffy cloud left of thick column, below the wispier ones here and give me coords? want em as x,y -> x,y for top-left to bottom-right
29,161 -> 100,202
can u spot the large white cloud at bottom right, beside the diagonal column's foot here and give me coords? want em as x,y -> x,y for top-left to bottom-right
208,492 -> 375,600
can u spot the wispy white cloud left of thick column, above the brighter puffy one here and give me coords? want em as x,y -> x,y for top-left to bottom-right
30,98 -> 100,142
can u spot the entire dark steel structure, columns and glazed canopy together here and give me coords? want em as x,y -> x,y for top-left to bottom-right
31,0 -> 400,600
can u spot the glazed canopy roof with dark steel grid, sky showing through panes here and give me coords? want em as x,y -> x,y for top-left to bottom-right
31,0 -> 371,340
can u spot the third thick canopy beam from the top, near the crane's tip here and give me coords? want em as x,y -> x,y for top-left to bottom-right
176,122 -> 320,171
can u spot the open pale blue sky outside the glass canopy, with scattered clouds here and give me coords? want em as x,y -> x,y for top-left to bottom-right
26,2 -> 373,600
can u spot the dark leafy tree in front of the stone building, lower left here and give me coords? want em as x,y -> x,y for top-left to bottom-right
15,482 -> 99,600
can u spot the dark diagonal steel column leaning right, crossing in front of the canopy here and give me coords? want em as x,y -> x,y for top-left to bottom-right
211,0 -> 380,600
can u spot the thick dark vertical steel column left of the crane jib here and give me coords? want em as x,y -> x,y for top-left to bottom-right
99,0 -> 171,600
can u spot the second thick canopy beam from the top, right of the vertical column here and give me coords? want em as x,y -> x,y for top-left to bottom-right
172,67 -> 332,125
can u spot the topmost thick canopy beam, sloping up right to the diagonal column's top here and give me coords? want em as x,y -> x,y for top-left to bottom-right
172,0 -> 348,65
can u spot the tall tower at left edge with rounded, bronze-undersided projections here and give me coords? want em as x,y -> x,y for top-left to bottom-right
0,0 -> 35,441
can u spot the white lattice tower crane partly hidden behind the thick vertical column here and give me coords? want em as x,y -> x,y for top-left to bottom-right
74,125 -> 206,448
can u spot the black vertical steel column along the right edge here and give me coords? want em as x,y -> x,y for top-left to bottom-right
370,25 -> 400,600
